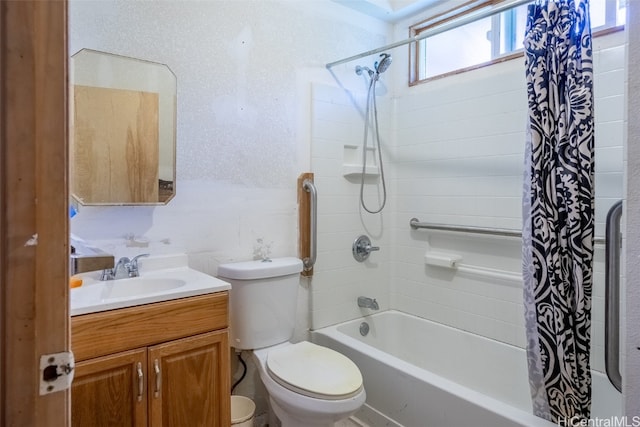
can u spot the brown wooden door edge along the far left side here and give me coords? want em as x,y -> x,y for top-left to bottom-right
0,0 -> 69,427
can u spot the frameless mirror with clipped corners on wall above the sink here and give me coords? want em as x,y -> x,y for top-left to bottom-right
69,49 -> 176,205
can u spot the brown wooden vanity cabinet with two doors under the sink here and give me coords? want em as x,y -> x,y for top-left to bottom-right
71,292 -> 231,427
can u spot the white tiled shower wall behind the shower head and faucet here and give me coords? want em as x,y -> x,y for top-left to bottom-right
311,84 -> 393,328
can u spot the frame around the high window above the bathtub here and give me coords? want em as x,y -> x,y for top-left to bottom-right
408,0 -> 624,87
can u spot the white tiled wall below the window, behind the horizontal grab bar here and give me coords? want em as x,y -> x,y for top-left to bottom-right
391,33 -> 625,376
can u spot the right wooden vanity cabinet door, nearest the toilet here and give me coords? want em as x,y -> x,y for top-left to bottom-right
148,329 -> 231,427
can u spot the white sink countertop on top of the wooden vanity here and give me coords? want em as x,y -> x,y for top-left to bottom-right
70,255 -> 231,316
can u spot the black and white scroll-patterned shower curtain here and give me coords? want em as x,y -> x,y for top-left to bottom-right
522,0 -> 594,425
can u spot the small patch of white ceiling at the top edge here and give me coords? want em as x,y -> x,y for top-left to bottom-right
333,0 -> 450,22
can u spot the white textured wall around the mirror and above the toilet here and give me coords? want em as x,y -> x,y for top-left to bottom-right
69,0 -> 388,268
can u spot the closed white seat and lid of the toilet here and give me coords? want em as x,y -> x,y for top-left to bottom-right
266,341 -> 362,400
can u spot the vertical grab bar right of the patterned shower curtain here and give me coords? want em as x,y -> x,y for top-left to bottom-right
604,200 -> 622,392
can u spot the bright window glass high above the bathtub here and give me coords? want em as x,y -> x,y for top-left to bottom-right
409,0 -> 625,84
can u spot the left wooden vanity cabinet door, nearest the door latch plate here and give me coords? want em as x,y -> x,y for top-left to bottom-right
71,348 -> 147,427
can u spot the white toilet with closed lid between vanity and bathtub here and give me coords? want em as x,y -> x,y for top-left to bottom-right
218,258 -> 366,427
